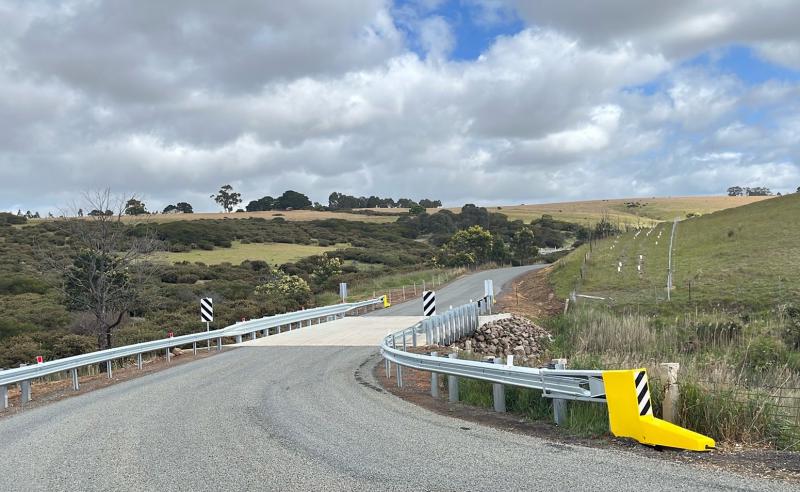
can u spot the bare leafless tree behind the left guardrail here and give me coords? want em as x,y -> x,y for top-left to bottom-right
47,189 -> 160,348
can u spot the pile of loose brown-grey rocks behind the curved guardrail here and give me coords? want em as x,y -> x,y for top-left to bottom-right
454,316 -> 553,362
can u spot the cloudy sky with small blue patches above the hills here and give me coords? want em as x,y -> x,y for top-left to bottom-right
0,0 -> 800,212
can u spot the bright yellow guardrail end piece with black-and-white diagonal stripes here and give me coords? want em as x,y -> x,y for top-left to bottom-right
603,369 -> 715,451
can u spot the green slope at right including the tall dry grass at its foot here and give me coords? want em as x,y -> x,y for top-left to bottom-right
548,194 -> 800,450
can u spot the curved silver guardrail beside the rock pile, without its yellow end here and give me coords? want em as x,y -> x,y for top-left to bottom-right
380,303 -> 606,403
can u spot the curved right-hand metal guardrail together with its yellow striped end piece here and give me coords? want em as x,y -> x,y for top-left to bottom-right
380,302 -> 715,451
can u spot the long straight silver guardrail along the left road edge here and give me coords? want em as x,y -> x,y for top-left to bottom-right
0,297 -> 383,406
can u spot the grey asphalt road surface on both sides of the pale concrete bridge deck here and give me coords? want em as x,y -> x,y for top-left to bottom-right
0,271 -> 788,491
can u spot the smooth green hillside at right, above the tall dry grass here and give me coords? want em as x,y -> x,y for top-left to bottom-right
553,194 -> 800,309
